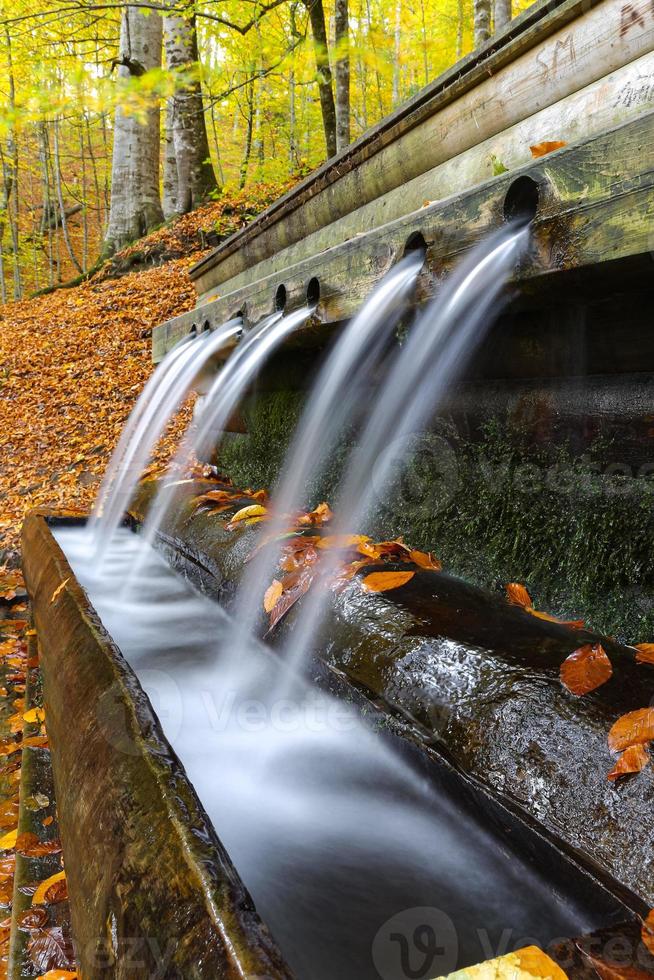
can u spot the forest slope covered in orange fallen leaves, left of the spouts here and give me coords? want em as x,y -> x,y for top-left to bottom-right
0,176 -> 294,565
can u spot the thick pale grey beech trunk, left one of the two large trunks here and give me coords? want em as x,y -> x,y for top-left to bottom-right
105,5 -> 163,254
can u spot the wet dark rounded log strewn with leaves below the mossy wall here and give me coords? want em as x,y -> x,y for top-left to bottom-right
128,484 -> 654,910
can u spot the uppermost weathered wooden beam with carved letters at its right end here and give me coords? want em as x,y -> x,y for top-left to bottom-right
193,0 -> 654,295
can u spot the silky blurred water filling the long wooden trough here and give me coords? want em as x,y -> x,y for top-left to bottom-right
56,529 -> 599,980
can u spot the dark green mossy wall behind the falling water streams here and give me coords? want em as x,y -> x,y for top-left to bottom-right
218,389 -> 654,643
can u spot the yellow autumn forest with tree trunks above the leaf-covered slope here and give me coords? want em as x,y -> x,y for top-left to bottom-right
0,0 -> 527,302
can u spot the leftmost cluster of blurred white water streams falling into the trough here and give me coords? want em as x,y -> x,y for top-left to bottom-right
90,318 -> 242,562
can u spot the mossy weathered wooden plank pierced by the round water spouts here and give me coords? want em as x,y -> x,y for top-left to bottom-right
153,112 -> 654,360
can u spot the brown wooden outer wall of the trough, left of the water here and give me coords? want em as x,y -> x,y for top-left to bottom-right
22,512 -> 292,980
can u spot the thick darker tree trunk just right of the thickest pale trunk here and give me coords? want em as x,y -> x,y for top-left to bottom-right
164,7 -> 217,214
